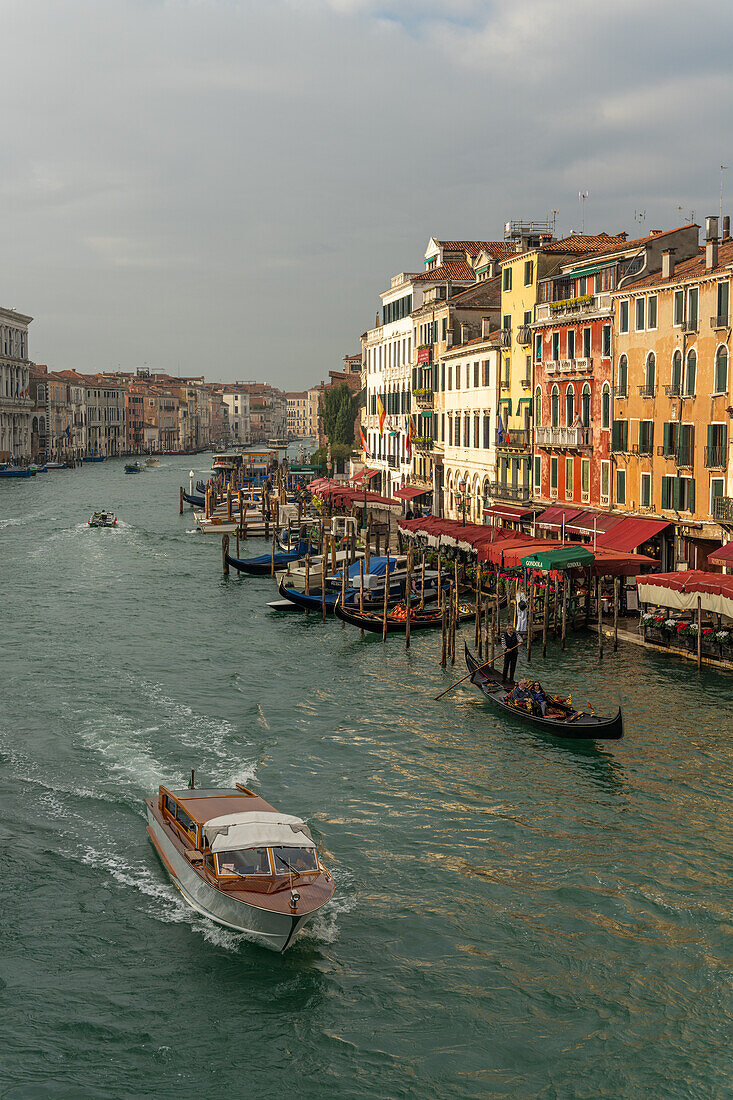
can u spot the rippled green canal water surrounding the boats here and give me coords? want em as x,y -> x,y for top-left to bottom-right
0,455 -> 733,1100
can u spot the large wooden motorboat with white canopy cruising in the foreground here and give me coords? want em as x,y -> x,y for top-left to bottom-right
145,783 -> 333,952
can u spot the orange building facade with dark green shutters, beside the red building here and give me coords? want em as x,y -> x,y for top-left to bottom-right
611,218 -> 733,569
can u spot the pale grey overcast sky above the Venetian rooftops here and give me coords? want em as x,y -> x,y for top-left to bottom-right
0,0 -> 733,388
